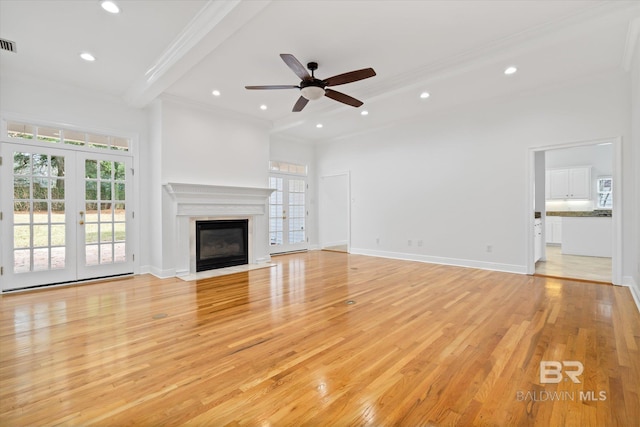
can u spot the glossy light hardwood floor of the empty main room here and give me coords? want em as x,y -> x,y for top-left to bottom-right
0,251 -> 640,426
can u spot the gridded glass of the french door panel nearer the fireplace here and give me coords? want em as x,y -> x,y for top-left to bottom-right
84,160 -> 127,266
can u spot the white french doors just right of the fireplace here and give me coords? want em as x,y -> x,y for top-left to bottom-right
269,174 -> 309,254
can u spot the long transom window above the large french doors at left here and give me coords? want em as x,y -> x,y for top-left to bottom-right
7,122 -> 130,151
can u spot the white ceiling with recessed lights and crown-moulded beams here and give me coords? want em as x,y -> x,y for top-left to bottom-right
0,0 -> 640,141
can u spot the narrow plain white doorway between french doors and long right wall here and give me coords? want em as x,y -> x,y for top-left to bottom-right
319,172 -> 350,252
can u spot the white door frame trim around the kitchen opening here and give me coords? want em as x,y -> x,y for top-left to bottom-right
525,136 -> 623,285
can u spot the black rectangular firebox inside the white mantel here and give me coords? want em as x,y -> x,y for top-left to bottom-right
196,219 -> 249,271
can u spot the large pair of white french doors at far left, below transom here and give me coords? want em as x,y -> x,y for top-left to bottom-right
0,142 -> 133,290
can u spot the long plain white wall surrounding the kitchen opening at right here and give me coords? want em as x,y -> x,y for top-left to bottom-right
317,70 -> 636,274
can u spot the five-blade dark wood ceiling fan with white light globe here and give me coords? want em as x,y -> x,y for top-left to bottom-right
245,53 -> 376,112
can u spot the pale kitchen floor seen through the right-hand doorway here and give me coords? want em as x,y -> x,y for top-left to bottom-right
536,245 -> 612,283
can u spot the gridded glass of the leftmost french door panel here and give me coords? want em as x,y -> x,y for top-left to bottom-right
13,152 -> 66,273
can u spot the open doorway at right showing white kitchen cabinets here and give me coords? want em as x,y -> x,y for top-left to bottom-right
528,138 -> 621,284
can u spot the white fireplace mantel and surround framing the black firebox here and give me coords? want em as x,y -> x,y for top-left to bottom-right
163,182 -> 274,276
